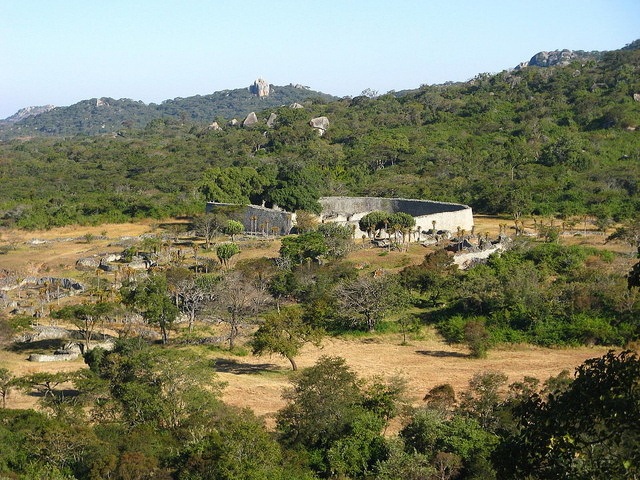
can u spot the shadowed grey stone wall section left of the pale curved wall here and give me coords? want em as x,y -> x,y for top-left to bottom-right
207,202 -> 296,235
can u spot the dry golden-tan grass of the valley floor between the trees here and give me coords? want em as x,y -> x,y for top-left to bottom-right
0,216 -> 629,417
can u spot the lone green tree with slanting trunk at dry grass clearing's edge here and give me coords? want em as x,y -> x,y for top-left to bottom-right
251,307 -> 322,370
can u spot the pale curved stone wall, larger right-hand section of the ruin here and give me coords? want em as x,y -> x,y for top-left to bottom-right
319,197 -> 473,236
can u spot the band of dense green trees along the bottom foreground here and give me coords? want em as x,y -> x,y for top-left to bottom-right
0,340 -> 640,480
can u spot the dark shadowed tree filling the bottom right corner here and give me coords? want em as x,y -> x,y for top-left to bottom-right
495,351 -> 640,480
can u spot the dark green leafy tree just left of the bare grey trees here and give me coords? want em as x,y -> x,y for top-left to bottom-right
120,274 -> 178,343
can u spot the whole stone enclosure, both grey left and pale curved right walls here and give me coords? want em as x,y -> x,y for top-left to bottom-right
207,197 -> 473,236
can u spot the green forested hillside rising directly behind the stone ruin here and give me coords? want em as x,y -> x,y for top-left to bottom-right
0,42 -> 640,228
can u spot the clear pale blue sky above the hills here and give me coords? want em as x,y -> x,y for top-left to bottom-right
0,0 -> 640,119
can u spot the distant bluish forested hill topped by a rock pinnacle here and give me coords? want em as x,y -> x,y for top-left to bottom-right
0,85 -> 336,139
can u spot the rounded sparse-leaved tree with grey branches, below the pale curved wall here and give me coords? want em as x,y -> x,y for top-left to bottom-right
336,276 -> 405,332
